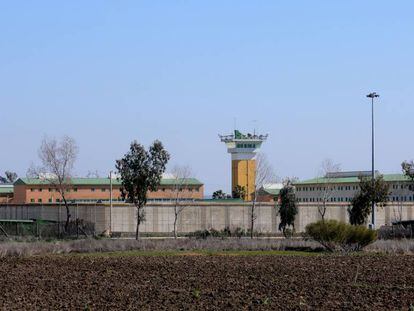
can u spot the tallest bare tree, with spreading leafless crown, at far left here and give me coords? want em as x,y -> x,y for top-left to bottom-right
28,136 -> 78,231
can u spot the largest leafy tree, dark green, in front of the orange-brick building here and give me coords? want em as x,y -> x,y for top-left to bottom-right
116,140 -> 170,240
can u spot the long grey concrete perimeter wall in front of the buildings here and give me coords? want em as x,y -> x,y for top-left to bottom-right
0,202 -> 414,234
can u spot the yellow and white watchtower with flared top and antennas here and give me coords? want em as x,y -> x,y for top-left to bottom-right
219,130 -> 268,201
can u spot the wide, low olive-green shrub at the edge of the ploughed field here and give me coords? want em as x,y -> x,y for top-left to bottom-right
305,220 -> 377,252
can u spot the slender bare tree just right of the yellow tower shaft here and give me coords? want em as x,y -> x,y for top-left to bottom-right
250,153 -> 276,239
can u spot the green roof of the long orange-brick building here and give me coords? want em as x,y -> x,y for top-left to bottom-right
14,177 -> 203,186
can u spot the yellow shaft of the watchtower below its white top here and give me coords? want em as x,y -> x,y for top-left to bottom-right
232,160 -> 256,201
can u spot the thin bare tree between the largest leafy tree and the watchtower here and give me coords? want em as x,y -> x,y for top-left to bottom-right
171,165 -> 192,239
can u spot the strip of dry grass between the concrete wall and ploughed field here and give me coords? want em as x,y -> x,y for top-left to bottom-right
0,238 -> 414,258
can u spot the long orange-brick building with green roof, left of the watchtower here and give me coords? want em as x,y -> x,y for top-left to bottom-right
12,178 -> 204,204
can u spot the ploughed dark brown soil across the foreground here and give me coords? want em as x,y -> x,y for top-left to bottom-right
0,255 -> 414,310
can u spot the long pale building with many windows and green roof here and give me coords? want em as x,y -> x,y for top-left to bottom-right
294,171 -> 414,203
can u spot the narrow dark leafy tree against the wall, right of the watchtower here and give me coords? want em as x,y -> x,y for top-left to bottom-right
279,179 -> 298,237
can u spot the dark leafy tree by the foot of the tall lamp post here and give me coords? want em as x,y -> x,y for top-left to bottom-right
348,175 -> 389,225
